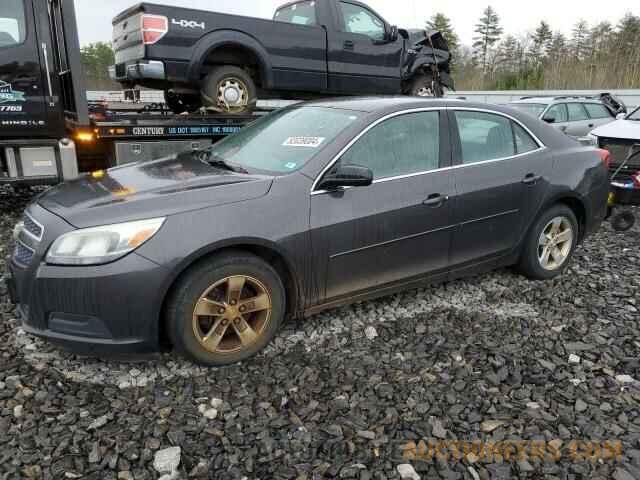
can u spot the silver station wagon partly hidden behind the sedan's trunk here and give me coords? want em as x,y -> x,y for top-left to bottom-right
510,97 -> 616,137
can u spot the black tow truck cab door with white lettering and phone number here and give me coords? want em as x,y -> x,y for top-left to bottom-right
0,0 -> 47,138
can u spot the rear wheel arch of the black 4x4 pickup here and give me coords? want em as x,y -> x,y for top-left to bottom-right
187,30 -> 273,88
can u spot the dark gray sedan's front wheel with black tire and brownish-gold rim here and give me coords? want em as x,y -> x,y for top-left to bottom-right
165,252 -> 286,367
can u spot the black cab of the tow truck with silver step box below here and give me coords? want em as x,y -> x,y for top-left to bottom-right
0,0 -> 89,184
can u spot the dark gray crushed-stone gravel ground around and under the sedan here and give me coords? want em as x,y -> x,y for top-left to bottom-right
0,188 -> 640,480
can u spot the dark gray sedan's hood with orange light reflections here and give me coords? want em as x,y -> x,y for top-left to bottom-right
37,153 -> 273,228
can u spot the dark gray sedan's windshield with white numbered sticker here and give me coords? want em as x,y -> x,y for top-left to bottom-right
207,106 -> 362,174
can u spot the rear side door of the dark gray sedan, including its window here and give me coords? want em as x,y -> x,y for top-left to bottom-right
451,109 -> 552,268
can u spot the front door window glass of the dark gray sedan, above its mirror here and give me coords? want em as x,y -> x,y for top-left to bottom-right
340,112 -> 440,180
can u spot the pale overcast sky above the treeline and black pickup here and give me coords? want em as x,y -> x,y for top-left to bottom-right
75,0 -> 640,45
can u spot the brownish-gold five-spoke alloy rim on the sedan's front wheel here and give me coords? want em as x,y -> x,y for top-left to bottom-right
193,275 -> 272,354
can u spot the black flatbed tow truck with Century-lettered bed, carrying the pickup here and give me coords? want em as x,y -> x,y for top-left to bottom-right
0,0 -> 265,187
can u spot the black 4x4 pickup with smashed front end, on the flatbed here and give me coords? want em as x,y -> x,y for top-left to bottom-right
111,0 -> 454,113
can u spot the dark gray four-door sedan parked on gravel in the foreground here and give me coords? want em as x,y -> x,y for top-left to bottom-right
10,97 -> 609,365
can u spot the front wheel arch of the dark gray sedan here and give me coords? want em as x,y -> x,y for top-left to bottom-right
158,238 -> 303,345
